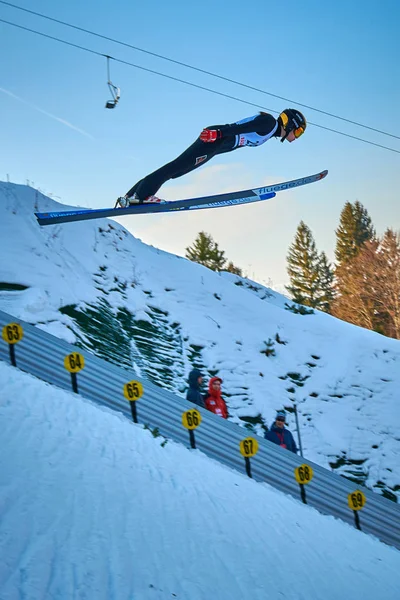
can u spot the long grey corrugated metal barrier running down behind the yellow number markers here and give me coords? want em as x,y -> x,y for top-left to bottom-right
0,311 -> 400,549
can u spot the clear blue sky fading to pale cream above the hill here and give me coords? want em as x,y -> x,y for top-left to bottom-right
0,0 -> 400,284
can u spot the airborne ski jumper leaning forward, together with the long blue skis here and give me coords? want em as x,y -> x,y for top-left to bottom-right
35,108 -> 328,226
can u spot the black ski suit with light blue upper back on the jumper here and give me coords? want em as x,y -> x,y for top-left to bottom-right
126,113 -> 280,200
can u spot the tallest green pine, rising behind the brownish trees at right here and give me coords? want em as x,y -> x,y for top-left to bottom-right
335,200 -> 375,264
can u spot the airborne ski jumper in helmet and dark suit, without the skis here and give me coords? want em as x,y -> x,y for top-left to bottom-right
115,108 -> 307,208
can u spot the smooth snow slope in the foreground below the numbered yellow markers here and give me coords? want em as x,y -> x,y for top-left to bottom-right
0,363 -> 400,600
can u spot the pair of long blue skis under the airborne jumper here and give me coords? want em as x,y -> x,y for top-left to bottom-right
35,171 -> 328,226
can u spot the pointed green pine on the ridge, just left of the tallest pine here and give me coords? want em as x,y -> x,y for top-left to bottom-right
286,221 -> 333,309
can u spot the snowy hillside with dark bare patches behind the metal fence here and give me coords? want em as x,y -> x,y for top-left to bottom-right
0,183 -> 400,499
